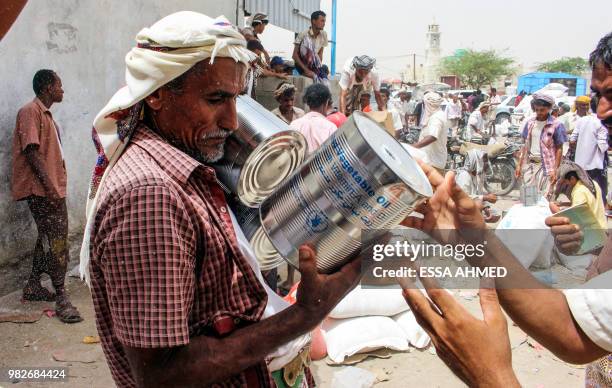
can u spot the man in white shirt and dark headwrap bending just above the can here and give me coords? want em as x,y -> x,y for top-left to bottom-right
340,55 -> 383,116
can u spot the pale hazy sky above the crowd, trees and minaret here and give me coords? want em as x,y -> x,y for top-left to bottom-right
321,0 -> 612,77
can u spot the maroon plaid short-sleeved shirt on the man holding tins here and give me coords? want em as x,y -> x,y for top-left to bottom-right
90,127 -> 273,387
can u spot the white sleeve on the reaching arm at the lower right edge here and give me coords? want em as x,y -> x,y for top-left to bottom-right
564,271 -> 612,352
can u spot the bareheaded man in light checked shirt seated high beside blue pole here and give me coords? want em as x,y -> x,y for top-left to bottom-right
293,11 -> 329,83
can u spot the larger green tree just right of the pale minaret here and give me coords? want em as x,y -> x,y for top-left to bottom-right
441,49 -> 514,89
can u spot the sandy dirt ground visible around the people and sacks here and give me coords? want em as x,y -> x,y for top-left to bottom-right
0,192 -> 604,388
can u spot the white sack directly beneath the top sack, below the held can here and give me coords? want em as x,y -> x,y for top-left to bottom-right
321,316 -> 408,363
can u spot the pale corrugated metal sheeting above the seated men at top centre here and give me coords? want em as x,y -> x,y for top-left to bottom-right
244,0 -> 321,32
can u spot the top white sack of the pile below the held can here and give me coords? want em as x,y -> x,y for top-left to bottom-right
329,286 -> 410,319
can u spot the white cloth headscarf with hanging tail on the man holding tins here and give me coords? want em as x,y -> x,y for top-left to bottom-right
79,11 -> 254,284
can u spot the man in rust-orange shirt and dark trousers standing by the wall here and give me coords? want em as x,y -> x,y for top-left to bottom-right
11,70 -> 83,323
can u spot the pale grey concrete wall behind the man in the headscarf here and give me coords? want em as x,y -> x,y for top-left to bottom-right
0,0 -> 244,266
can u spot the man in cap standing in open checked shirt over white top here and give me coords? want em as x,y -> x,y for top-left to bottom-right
515,93 -> 567,196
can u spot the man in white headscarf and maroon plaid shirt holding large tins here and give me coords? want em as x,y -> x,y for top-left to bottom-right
80,12 -> 360,387
